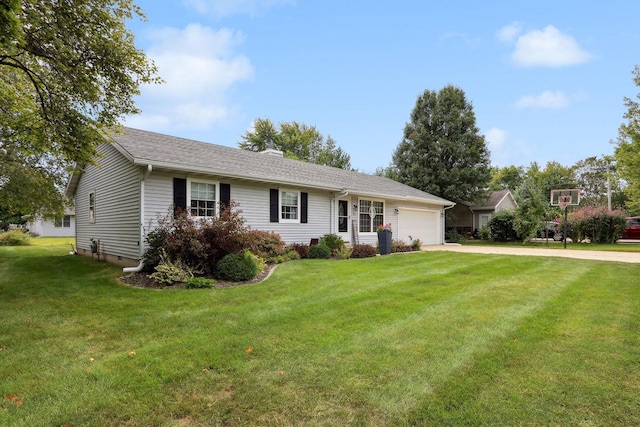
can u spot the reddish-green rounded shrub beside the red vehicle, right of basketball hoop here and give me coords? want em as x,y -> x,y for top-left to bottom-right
561,206 -> 627,244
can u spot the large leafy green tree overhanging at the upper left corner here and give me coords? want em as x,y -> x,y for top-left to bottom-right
0,0 -> 159,219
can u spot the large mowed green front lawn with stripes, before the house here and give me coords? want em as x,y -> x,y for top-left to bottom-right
0,245 -> 640,426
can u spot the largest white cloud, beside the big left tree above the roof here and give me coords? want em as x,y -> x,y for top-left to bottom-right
127,24 -> 254,131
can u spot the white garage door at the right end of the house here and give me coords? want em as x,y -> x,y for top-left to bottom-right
398,208 -> 442,245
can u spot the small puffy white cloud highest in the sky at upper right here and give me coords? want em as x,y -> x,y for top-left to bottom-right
498,23 -> 592,67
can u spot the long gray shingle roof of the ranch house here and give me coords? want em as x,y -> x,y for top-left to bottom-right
113,128 -> 453,205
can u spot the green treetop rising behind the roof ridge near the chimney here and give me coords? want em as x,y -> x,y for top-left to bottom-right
238,118 -> 351,169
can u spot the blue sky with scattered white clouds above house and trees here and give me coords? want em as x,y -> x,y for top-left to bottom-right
126,0 -> 640,173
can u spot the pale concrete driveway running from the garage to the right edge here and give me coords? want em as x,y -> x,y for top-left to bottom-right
421,243 -> 640,263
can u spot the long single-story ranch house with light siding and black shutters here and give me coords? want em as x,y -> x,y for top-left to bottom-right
67,128 -> 454,265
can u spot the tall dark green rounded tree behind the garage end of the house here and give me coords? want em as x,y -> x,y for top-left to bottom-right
387,85 -> 491,202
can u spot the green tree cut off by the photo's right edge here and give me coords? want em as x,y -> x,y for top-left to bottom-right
615,66 -> 640,214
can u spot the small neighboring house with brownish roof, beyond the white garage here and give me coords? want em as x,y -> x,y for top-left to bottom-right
447,190 -> 518,235
